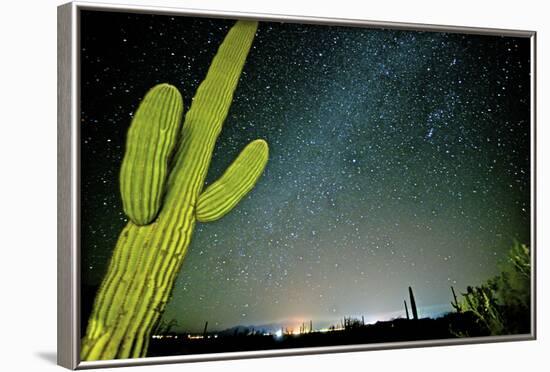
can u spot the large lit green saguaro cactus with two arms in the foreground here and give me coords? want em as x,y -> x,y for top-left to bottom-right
81,21 -> 268,360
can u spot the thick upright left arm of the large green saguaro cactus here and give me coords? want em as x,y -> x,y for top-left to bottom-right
120,84 -> 183,225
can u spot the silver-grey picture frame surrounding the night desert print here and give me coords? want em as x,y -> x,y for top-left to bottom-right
57,1 -> 537,369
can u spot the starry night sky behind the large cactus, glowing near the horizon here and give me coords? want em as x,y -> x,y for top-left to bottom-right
81,11 -> 531,331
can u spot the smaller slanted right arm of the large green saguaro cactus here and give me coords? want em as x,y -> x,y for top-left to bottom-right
196,140 -> 269,222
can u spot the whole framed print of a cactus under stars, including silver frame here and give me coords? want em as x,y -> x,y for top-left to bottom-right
58,2 -> 535,369
